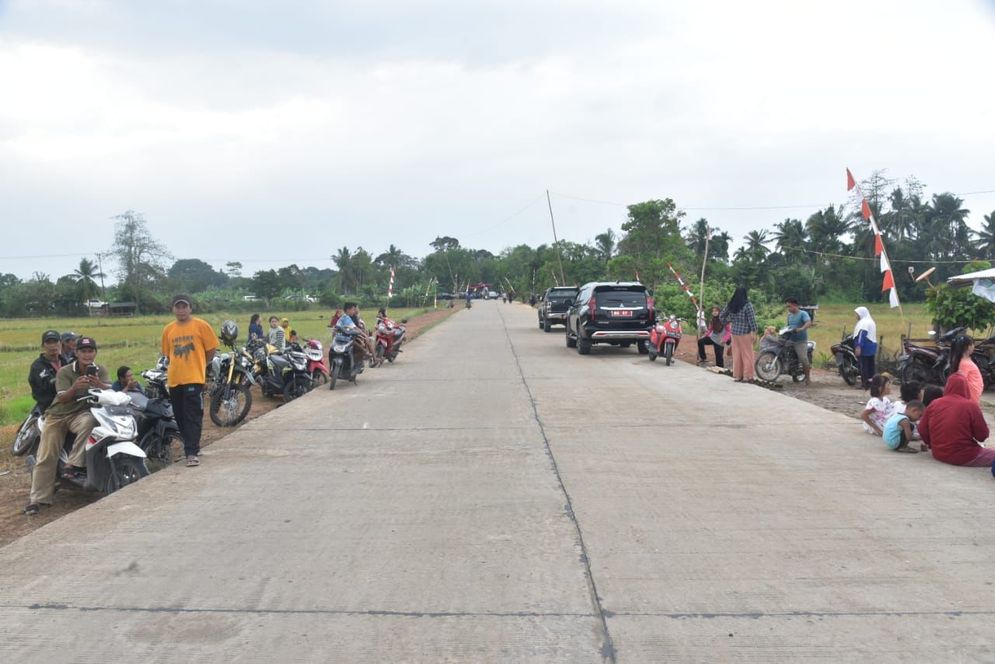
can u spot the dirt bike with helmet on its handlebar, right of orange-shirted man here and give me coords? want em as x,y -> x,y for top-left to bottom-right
208,320 -> 256,427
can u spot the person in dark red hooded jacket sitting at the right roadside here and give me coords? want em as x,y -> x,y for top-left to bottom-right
919,373 -> 995,466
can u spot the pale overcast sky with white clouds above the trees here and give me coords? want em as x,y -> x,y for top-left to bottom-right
0,0 -> 995,277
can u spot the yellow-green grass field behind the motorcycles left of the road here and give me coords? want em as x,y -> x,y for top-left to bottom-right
0,309 -> 425,425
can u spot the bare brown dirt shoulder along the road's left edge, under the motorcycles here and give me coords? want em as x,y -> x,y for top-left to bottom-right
0,308 -> 460,547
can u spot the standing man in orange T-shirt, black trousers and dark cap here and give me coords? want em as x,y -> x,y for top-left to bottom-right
162,295 -> 218,466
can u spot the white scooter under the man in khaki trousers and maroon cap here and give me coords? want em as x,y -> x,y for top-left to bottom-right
27,389 -> 149,493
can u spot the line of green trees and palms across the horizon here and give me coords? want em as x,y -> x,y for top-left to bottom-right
0,172 -> 995,316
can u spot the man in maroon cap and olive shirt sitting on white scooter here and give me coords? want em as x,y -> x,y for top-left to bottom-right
24,337 -> 110,514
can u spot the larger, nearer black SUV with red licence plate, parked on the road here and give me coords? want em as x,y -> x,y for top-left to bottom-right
566,281 -> 655,355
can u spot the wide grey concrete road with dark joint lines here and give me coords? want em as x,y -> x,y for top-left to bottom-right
0,303 -> 995,663
